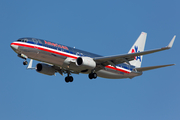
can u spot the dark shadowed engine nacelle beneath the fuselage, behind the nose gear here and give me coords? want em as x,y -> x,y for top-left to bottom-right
36,63 -> 56,75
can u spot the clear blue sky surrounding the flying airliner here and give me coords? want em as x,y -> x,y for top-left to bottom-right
0,0 -> 180,120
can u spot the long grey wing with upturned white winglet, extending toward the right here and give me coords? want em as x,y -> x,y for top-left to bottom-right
94,36 -> 176,67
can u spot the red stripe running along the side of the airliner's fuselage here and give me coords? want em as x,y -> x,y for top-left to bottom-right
11,43 -> 130,74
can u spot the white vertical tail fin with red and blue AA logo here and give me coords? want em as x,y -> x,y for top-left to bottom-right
128,32 -> 147,68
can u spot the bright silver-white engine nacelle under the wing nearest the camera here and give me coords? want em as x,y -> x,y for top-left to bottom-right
76,57 -> 96,69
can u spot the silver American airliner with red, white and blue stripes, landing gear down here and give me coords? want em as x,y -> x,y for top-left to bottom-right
10,32 -> 176,83
